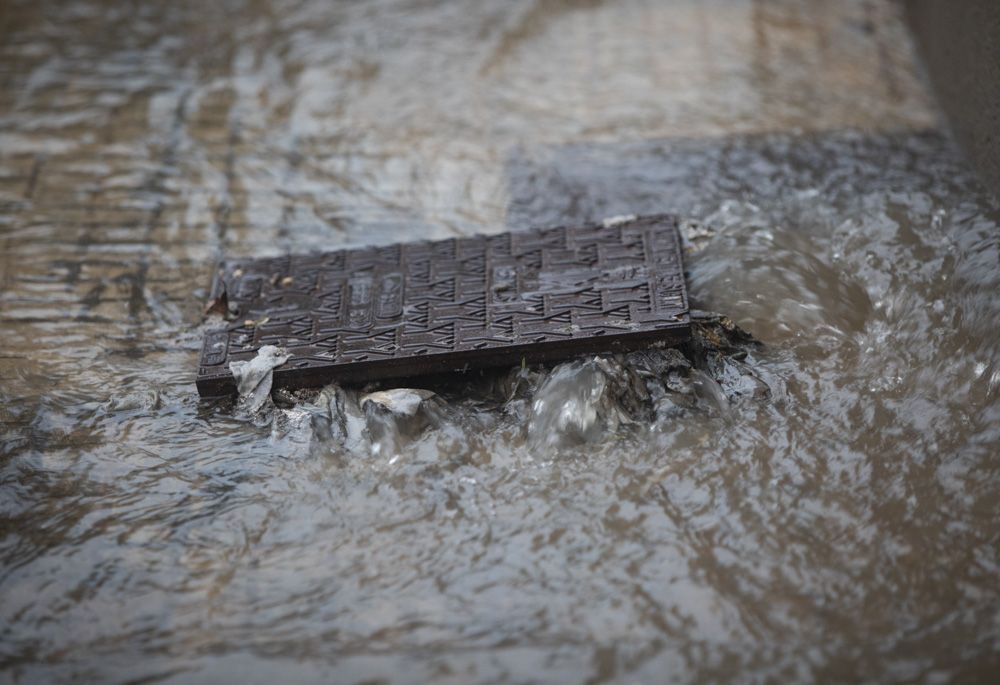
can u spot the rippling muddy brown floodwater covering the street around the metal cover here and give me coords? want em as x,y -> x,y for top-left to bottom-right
0,0 -> 1000,683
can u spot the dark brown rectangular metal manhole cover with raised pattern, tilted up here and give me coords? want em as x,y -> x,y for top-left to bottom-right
197,216 -> 690,396
